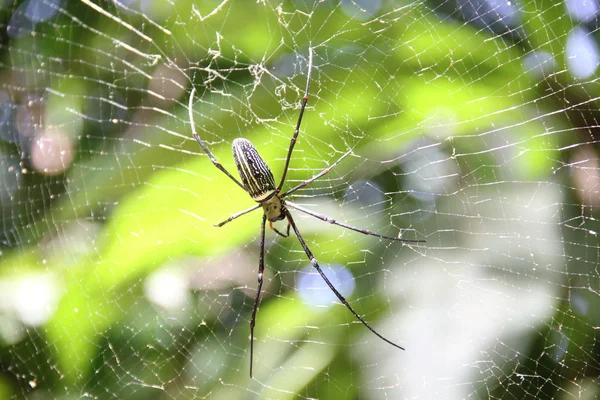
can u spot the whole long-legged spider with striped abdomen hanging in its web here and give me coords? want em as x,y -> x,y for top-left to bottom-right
188,48 -> 425,378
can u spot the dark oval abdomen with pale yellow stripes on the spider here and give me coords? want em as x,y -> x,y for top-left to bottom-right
232,138 -> 276,203
